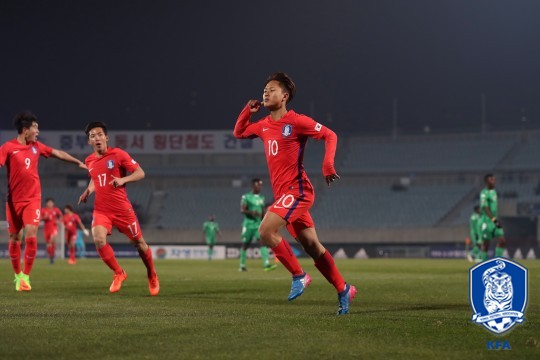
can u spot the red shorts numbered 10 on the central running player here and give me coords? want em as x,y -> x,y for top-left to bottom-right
268,191 -> 315,239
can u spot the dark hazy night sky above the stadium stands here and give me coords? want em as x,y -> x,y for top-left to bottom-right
0,0 -> 540,132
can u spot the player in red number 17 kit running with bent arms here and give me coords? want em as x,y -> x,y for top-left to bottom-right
79,121 -> 159,296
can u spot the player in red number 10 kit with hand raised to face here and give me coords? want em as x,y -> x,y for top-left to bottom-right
234,72 -> 356,315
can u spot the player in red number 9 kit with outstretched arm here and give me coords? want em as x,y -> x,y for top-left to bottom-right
0,111 -> 86,291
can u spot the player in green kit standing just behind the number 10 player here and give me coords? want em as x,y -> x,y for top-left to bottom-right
239,178 -> 277,271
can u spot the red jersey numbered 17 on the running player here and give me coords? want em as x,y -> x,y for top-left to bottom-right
85,147 -> 139,214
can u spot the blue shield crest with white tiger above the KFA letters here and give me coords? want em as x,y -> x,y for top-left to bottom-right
469,258 -> 528,334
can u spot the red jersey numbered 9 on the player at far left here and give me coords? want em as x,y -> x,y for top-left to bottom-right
0,139 -> 53,203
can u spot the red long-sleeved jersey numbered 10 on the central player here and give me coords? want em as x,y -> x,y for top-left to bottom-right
234,106 -> 337,196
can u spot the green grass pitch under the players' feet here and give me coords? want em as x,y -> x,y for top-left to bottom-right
0,259 -> 540,360
